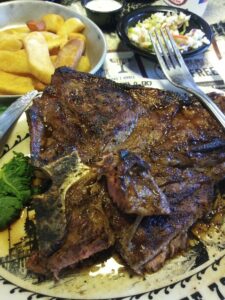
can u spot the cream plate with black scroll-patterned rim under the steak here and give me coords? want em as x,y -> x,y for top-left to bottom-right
0,81 -> 225,300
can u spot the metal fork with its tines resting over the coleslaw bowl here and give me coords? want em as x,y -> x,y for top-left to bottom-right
149,28 -> 225,129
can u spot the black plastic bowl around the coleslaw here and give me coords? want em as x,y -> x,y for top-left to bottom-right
117,6 -> 213,60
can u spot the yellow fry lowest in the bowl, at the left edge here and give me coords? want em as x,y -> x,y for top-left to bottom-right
0,71 -> 34,95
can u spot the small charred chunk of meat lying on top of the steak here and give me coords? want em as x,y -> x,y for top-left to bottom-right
102,150 -> 170,216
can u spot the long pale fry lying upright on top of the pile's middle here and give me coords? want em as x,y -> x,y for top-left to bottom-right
24,31 -> 55,84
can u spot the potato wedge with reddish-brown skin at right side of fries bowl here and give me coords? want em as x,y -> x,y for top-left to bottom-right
54,39 -> 84,68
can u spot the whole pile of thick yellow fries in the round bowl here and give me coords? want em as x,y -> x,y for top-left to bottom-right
0,14 -> 90,95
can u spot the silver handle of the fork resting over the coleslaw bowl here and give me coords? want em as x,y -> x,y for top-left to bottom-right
183,87 -> 225,130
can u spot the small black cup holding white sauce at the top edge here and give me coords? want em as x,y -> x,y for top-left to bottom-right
81,0 -> 123,30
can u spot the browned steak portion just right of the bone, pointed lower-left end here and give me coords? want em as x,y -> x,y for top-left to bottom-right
27,170 -> 115,279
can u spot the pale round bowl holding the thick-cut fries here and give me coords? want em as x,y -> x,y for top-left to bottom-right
0,1 -> 106,101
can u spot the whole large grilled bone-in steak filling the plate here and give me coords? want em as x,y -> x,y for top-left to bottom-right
27,68 -> 225,277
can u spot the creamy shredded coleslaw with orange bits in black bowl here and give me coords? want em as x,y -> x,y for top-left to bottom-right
128,12 -> 210,52
